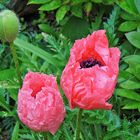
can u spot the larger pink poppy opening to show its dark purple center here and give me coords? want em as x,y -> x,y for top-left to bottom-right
61,30 -> 120,110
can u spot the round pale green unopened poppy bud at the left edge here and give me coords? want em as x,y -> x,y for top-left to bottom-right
0,10 -> 19,43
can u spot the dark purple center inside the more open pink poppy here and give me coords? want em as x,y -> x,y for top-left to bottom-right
80,58 -> 103,69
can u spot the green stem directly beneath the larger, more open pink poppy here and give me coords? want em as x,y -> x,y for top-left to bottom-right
75,109 -> 83,140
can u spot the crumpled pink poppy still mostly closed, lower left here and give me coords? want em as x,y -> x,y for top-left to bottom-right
18,72 -> 65,134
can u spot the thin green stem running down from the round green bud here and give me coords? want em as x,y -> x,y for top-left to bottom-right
10,42 -> 22,87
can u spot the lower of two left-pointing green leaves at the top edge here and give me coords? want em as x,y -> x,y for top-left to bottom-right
39,0 -> 61,11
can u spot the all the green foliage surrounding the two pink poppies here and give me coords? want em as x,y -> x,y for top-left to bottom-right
0,0 -> 140,140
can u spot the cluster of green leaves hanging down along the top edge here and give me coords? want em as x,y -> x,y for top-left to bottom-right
29,0 -> 115,23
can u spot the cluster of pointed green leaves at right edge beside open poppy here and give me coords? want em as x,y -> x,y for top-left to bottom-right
116,55 -> 140,111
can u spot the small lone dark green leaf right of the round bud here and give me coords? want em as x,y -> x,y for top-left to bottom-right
38,23 -> 57,36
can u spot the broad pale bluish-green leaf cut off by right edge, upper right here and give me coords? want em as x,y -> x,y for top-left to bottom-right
125,31 -> 140,49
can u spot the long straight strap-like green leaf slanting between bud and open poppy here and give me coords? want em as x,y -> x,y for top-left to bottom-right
14,38 -> 62,66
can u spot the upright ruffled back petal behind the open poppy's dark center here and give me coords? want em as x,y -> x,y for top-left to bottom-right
69,30 -> 110,64
